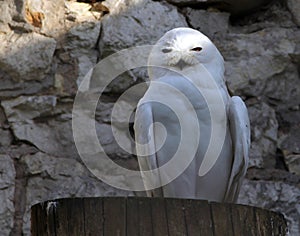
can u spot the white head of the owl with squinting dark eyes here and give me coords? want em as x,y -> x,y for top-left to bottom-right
149,28 -> 224,78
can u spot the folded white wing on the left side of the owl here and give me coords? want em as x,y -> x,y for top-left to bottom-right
134,103 -> 162,197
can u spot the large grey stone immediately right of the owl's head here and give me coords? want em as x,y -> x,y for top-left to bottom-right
221,28 -> 296,97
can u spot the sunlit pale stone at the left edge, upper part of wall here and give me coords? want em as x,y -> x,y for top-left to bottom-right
0,32 -> 56,83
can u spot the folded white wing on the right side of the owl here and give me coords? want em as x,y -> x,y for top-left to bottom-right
224,96 -> 250,202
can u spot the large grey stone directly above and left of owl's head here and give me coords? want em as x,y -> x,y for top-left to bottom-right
99,0 -> 187,58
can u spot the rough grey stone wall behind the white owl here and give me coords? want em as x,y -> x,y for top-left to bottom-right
0,0 -> 300,235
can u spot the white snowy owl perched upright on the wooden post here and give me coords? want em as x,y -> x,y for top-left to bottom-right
134,28 -> 250,202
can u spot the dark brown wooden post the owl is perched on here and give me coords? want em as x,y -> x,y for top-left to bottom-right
31,197 -> 287,236
